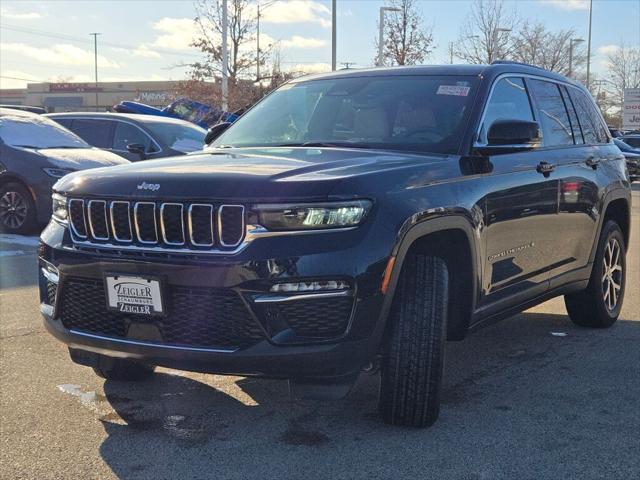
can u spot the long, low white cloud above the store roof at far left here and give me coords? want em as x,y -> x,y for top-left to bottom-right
0,43 -> 120,68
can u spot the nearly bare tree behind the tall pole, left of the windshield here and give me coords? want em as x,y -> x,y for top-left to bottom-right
191,0 -> 265,83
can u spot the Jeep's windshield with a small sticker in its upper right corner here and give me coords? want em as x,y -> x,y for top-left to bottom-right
212,75 -> 477,153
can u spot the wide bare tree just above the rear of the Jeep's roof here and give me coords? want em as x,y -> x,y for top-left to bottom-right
511,22 -> 587,76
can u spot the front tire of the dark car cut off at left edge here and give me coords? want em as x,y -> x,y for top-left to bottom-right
0,182 -> 36,234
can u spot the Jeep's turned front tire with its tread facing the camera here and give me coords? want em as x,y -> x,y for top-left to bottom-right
378,255 -> 449,427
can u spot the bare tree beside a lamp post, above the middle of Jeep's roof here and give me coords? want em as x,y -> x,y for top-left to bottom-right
376,0 -> 433,65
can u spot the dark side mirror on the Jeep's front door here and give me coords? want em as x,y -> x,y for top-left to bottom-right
476,120 -> 542,155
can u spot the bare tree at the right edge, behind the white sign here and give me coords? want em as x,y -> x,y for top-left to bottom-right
605,44 -> 640,124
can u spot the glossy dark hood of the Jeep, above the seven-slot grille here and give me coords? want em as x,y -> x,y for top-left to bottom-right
54,148 -> 451,201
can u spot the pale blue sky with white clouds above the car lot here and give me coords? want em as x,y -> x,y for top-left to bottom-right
0,0 -> 640,88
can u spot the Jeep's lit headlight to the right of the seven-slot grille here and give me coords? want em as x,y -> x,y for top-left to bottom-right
255,200 -> 371,230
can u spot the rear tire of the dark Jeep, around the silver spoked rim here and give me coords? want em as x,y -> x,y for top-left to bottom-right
564,220 -> 627,328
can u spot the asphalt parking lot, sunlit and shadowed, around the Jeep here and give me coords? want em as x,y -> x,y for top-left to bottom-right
0,184 -> 640,479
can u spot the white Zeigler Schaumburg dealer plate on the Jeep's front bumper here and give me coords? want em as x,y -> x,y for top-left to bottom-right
105,275 -> 163,315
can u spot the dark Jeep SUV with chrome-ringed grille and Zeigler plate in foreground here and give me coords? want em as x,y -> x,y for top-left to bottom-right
40,63 -> 630,426
